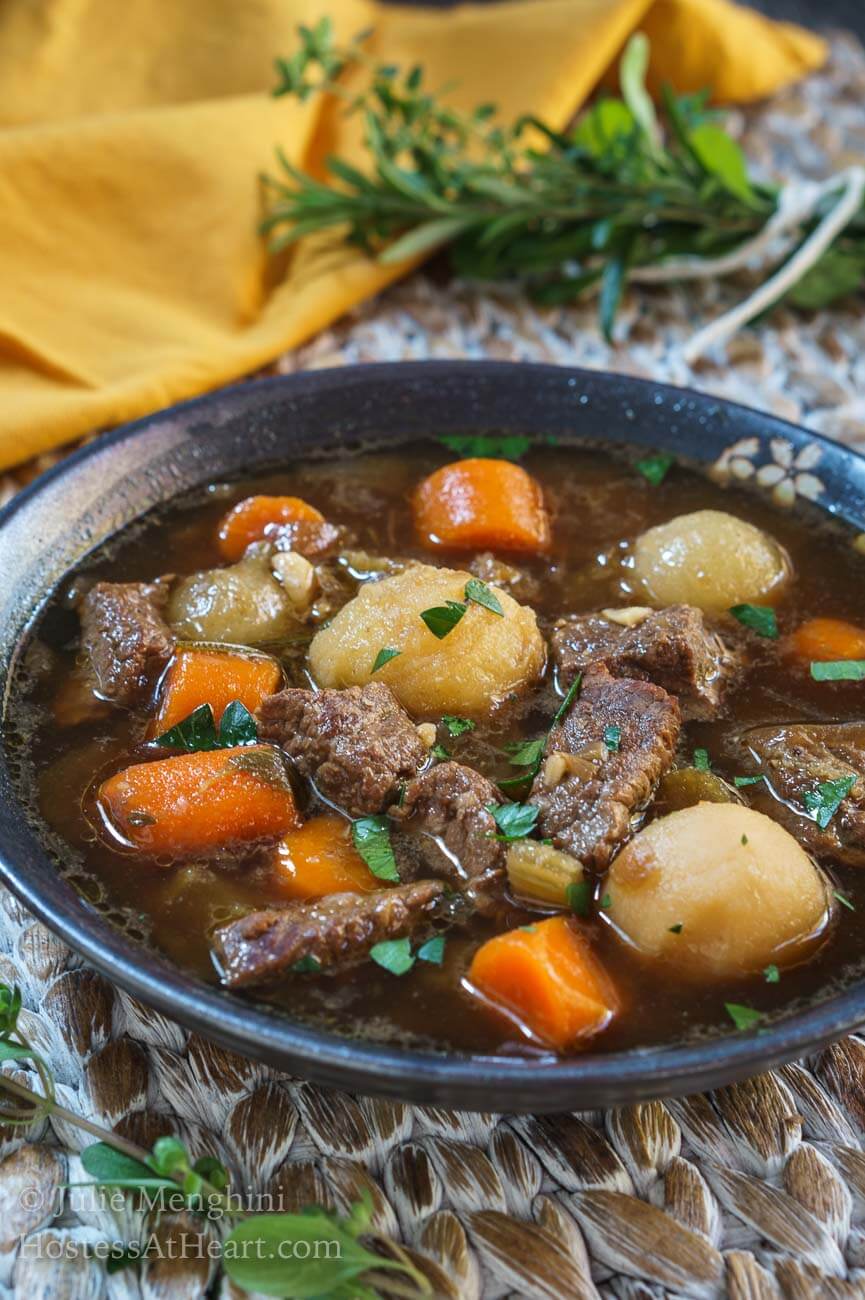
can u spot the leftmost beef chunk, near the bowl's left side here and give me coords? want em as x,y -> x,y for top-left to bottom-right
81,582 -> 174,707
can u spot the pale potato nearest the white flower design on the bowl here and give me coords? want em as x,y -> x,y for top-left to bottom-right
633,510 -> 790,612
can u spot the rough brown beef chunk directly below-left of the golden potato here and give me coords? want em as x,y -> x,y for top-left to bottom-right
259,681 -> 427,816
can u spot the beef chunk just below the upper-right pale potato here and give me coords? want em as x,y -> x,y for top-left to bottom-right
552,605 -> 735,718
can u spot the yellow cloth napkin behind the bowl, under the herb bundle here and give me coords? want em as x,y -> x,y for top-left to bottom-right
0,0 -> 825,468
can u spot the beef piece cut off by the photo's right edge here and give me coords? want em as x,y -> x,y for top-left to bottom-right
743,723 -> 865,867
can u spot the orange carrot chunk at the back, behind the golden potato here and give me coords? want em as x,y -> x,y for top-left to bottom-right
412,458 -> 550,553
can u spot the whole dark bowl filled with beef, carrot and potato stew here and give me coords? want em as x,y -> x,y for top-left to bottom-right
0,363 -> 865,1110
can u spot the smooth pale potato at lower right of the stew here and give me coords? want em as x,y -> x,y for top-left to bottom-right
606,803 -> 830,978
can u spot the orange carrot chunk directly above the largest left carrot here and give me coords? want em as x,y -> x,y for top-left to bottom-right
150,646 -> 282,736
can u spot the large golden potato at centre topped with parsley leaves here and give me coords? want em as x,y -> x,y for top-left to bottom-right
310,564 -> 545,718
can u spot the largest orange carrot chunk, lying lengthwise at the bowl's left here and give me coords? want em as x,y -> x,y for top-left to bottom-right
98,745 -> 300,858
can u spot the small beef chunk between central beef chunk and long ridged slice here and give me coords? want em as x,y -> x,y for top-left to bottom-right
390,763 -> 505,913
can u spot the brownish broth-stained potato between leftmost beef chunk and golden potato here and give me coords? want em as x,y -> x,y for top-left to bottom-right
166,555 -> 299,646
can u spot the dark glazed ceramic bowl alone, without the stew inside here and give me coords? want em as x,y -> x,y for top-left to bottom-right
0,363 -> 865,1110
